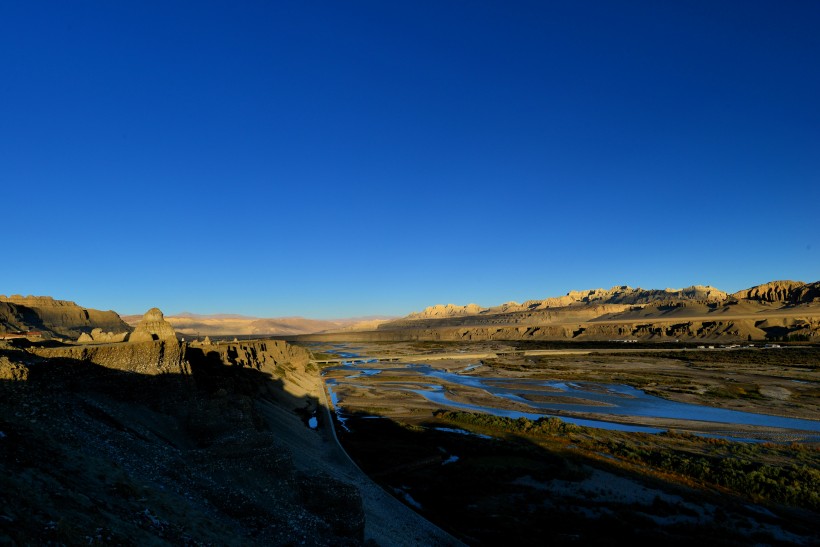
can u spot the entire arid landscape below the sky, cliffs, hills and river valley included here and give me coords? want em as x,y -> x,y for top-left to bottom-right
0,282 -> 820,545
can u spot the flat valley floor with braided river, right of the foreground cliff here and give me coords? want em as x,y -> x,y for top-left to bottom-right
311,342 -> 820,545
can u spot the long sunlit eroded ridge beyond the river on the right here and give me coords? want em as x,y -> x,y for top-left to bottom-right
305,281 -> 820,342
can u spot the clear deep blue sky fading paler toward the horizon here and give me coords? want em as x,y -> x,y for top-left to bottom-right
0,0 -> 820,318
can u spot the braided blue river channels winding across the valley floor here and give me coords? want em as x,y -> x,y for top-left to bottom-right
324,351 -> 820,441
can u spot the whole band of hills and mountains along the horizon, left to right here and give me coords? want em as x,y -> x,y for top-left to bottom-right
0,281 -> 820,340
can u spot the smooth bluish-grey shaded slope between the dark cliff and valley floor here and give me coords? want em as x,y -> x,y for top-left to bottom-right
259,378 -> 463,546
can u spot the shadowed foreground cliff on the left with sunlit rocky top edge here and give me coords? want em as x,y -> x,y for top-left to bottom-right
0,341 -> 364,545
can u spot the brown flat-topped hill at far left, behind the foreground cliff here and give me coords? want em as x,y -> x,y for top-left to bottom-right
0,295 -> 131,339
